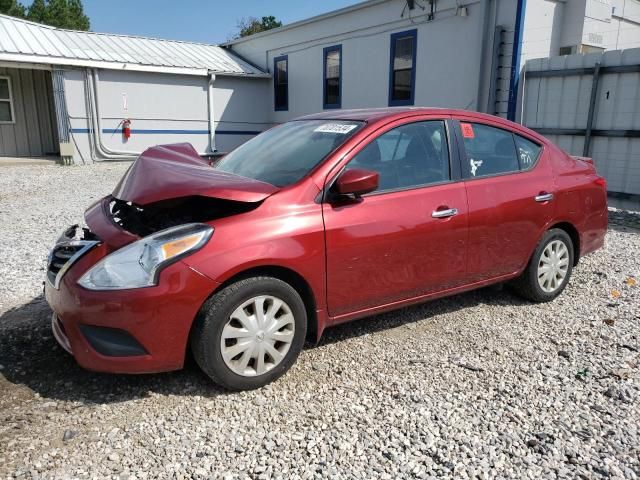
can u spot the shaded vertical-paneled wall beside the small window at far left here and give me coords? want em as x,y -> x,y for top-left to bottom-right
0,68 -> 58,157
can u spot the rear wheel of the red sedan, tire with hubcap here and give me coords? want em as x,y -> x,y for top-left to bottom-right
512,228 -> 575,303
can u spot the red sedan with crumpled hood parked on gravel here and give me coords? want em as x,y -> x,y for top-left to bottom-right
46,108 -> 607,389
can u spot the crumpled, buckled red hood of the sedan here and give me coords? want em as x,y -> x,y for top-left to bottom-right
113,143 -> 278,205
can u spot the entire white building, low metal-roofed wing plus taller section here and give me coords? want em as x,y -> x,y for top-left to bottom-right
0,0 -> 640,163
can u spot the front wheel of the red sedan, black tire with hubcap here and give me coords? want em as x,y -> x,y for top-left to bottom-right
190,277 -> 307,390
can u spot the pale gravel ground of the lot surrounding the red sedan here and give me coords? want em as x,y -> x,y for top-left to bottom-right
0,164 -> 640,479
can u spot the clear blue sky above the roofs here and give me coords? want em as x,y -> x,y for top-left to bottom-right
53,0 -> 359,43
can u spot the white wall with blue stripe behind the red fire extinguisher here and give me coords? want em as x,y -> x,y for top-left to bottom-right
65,69 -> 271,161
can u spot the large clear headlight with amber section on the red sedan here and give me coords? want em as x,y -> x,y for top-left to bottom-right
78,223 -> 213,290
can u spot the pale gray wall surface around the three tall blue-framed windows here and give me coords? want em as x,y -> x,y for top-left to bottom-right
232,0 -> 515,122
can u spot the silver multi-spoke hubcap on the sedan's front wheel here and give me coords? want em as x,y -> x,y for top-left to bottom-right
220,295 -> 295,377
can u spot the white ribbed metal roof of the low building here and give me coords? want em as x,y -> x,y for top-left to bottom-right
0,15 -> 268,77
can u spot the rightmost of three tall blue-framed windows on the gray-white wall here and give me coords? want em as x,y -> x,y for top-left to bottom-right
389,30 -> 418,107
